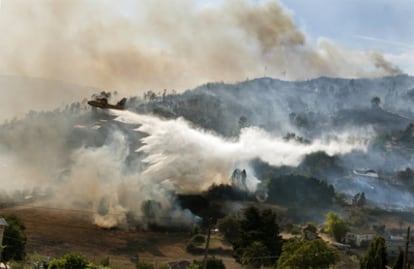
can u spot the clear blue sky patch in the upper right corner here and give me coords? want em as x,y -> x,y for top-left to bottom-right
281,0 -> 414,75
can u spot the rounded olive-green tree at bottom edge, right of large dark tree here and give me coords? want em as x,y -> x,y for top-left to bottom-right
277,239 -> 339,269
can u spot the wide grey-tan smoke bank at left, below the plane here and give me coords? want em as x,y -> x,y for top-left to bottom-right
0,112 -> 202,228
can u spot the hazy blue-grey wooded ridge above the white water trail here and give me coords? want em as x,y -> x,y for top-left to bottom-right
129,76 -> 414,137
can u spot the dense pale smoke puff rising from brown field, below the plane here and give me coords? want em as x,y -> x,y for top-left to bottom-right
60,131 -> 201,228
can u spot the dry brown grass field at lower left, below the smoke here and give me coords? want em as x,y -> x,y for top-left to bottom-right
0,205 -> 241,269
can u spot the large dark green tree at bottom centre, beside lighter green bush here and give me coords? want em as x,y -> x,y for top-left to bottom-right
232,207 -> 282,268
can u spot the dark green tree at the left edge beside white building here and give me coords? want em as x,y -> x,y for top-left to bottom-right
2,215 -> 27,262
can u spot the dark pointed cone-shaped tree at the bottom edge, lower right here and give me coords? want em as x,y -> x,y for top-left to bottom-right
359,236 -> 388,269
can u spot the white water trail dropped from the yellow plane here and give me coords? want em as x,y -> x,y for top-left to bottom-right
111,110 -> 366,192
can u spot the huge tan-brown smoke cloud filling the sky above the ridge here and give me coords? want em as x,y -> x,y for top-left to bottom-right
0,0 -> 400,96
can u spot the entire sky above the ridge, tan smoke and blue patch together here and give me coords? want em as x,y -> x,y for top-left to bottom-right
0,0 -> 414,119
